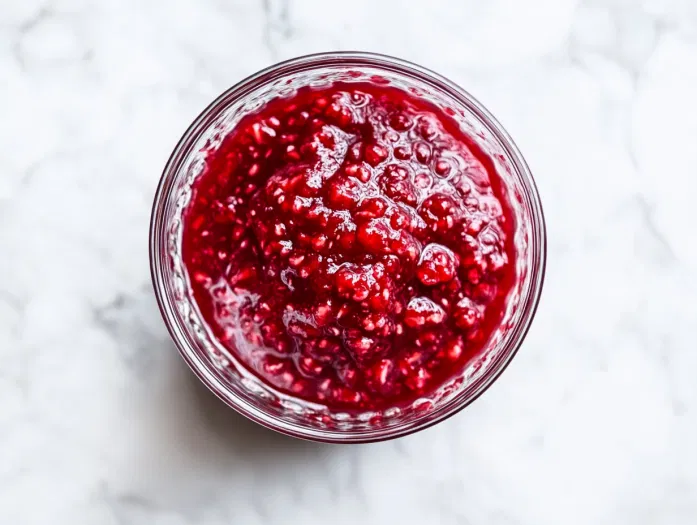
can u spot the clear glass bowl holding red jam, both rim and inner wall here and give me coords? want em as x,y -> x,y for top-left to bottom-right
150,52 -> 546,443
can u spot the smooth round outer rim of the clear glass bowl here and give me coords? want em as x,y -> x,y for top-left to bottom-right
149,51 -> 547,443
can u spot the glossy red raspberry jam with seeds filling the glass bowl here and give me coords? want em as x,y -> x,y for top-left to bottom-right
183,83 -> 515,410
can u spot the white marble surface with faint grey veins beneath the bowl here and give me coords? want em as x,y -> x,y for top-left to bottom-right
0,0 -> 697,525
